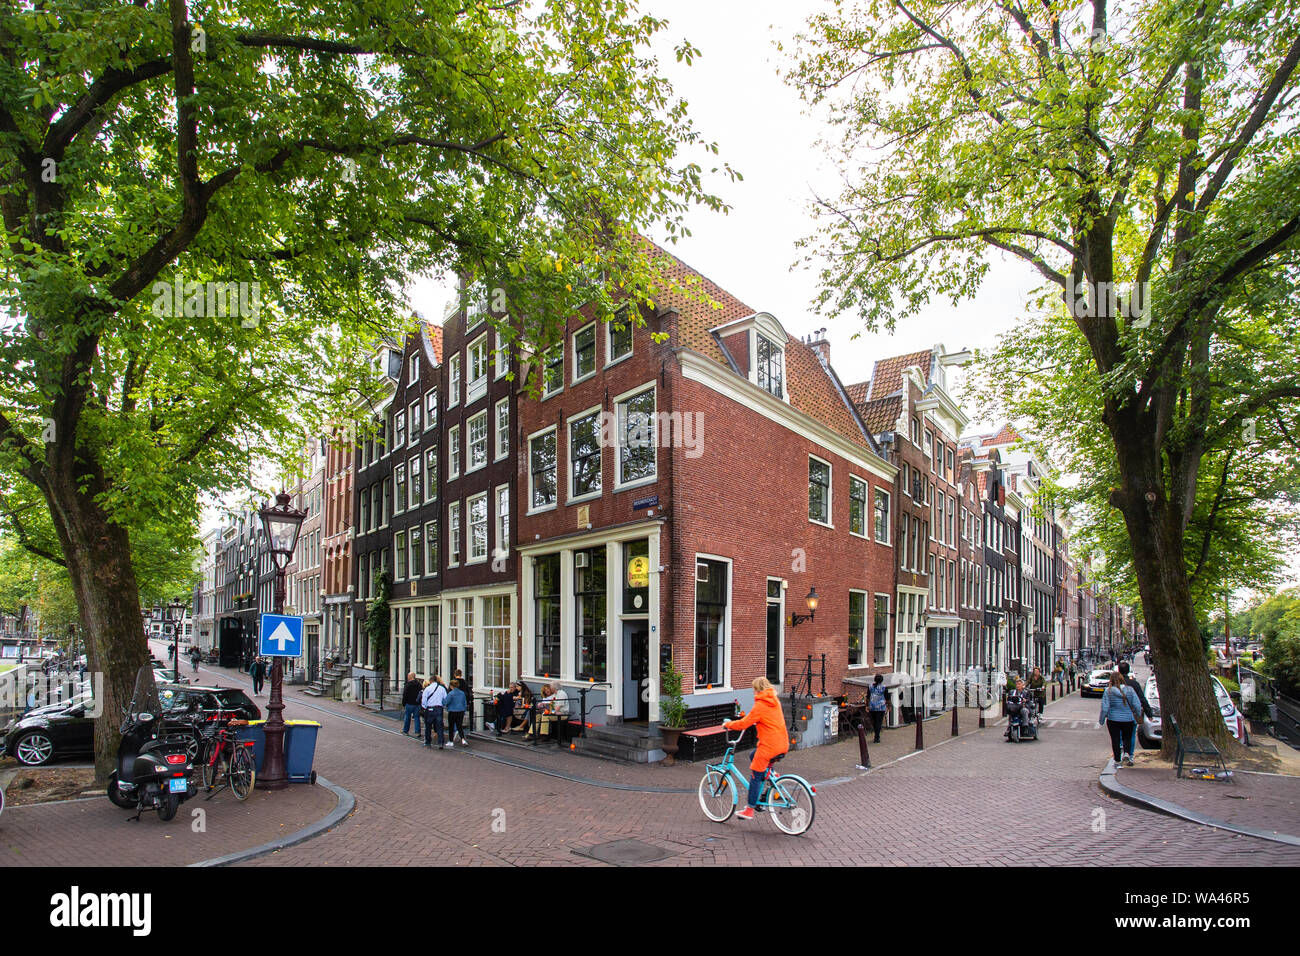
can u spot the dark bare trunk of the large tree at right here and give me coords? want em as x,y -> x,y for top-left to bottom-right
1113,436 -> 1231,760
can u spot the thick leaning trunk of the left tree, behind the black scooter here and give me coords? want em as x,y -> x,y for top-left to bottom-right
44,462 -> 150,786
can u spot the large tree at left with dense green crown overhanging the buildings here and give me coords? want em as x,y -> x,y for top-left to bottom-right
0,0 -> 731,778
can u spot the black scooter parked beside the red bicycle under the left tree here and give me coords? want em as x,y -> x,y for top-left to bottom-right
108,667 -> 198,822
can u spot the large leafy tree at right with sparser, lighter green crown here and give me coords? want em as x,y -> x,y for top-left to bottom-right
790,0 -> 1300,748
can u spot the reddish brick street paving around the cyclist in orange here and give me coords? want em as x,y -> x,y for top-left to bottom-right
165,658 -> 1300,866
